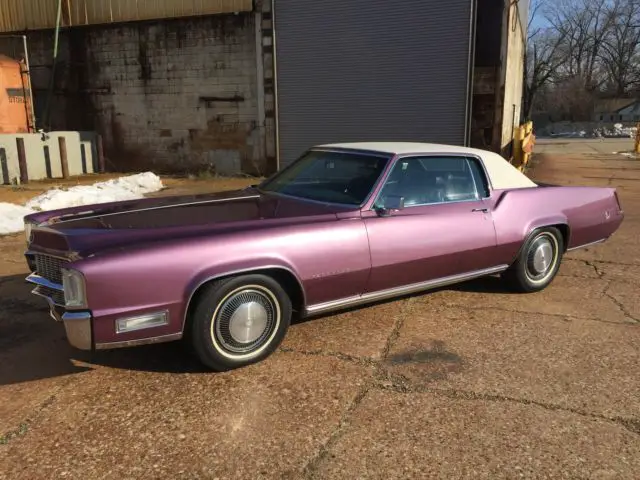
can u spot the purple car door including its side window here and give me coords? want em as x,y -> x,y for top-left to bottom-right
363,155 -> 496,293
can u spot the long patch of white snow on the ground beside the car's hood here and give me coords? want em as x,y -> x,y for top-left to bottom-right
0,172 -> 163,235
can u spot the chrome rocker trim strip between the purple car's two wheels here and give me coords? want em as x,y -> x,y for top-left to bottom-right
305,265 -> 509,315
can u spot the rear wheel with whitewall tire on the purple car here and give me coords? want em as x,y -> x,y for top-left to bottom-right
502,227 -> 564,293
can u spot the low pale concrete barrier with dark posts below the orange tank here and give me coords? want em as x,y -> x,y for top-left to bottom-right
0,132 -> 98,185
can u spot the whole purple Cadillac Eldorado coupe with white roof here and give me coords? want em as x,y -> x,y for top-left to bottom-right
25,143 -> 623,371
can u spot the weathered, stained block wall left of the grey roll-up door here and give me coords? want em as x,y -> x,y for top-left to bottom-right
22,13 -> 267,174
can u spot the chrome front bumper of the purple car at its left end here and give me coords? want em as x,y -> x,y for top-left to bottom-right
27,273 -> 93,350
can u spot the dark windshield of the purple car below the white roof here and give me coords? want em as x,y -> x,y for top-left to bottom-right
259,150 -> 389,205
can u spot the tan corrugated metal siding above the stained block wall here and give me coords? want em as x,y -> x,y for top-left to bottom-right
0,0 -> 253,32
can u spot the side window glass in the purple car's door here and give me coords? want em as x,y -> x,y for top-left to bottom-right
376,156 -> 488,206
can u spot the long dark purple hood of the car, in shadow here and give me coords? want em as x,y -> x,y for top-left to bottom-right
25,188 -> 359,257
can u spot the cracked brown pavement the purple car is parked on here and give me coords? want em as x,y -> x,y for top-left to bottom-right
0,141 -> 640,480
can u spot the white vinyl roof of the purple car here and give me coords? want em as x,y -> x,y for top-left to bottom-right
315,142 -> 537,190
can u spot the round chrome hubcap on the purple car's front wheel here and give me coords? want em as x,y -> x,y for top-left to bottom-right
215,289 -> 277,354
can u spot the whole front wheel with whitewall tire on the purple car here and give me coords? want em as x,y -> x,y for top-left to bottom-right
190,274 -> 291,371
